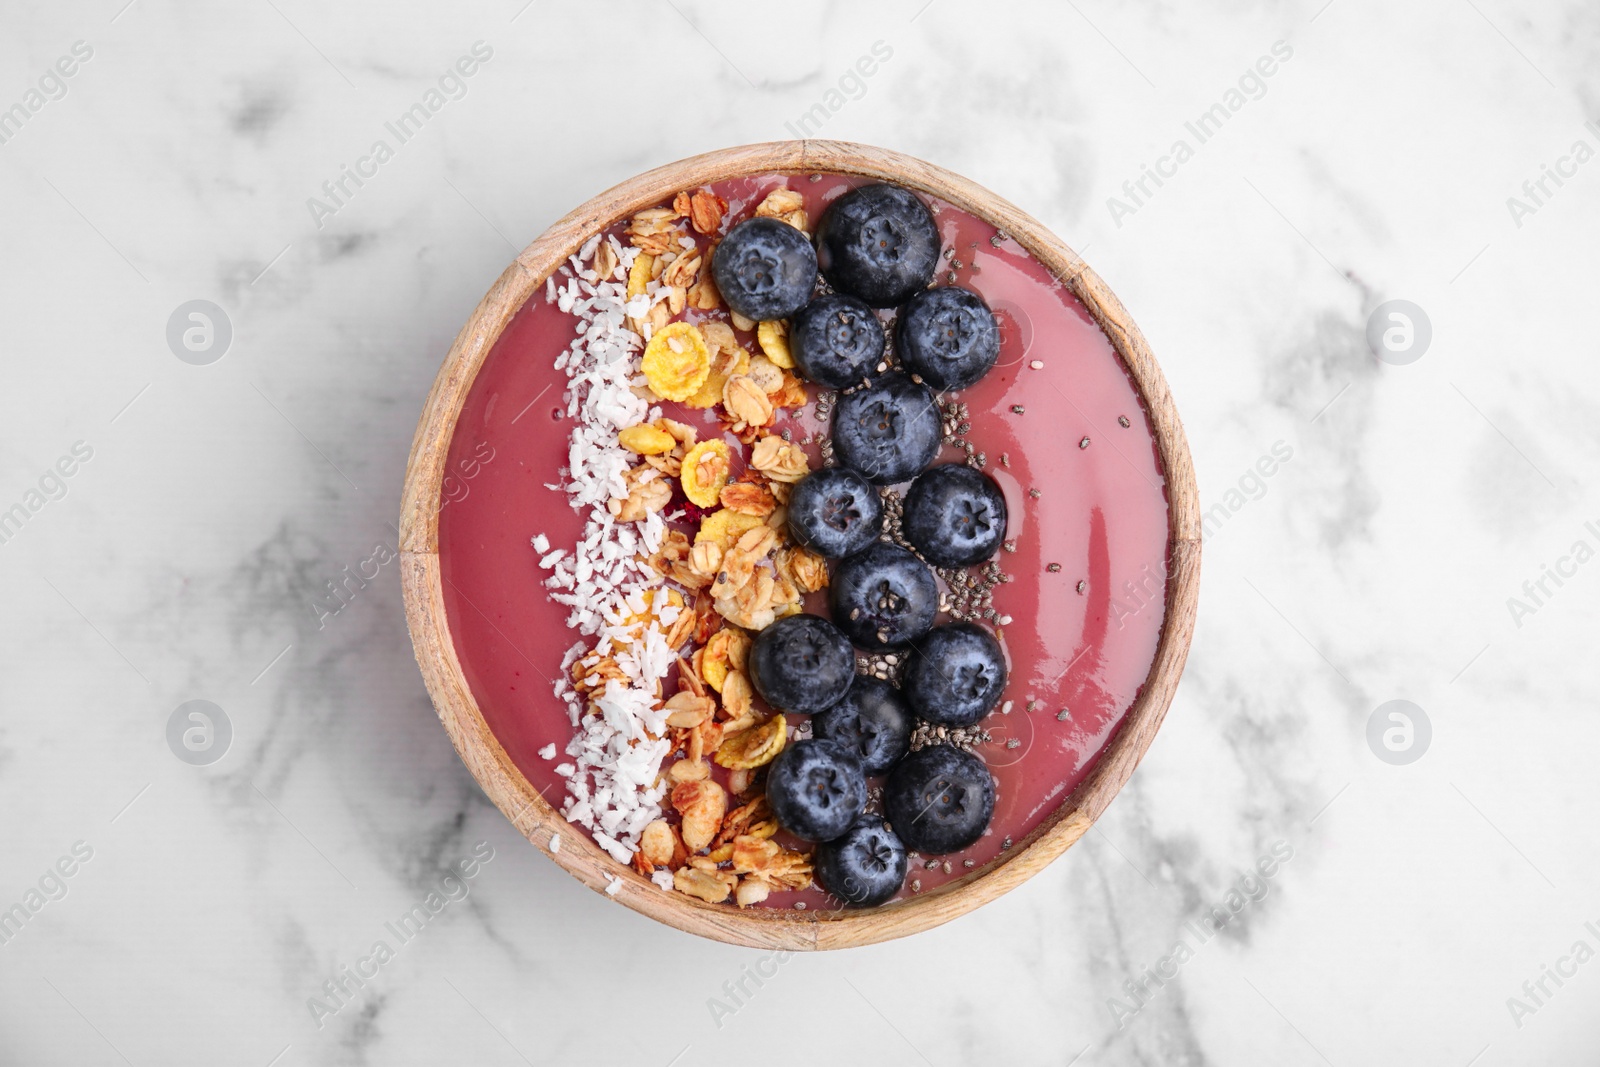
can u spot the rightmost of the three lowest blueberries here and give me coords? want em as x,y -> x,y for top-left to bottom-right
883,745 -> 995,856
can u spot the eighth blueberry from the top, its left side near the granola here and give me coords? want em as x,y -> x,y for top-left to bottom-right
827,541 -> 939,651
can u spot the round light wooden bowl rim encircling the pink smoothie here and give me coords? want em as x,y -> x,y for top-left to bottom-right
400,141 -> 1200,950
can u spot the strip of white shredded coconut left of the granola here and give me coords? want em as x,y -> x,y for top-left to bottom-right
531,235 -> 677,857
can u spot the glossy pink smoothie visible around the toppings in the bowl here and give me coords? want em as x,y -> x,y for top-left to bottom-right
438,174 -> 1168,909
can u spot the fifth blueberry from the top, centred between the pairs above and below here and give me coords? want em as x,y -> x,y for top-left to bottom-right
834,371 -> 942,485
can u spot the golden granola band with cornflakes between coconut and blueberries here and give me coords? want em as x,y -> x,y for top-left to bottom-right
540,190 -> 827,907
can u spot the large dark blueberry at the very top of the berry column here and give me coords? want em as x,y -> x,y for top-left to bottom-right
816,186 -> 939,307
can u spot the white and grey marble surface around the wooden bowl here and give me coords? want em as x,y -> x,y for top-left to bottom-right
0,0 -> 1600,1067
